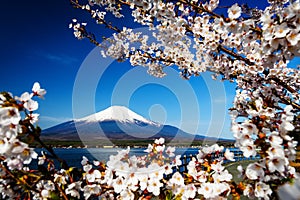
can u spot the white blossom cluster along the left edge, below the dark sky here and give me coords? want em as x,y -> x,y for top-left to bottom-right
0,82 -> 46,197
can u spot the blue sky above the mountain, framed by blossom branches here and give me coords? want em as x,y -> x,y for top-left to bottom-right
0,0 -> 278,138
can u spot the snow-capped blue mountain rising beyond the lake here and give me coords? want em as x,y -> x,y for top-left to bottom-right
42,106 -> 204,141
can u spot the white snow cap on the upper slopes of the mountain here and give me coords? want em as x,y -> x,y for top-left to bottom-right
76,106 -> 159,125
